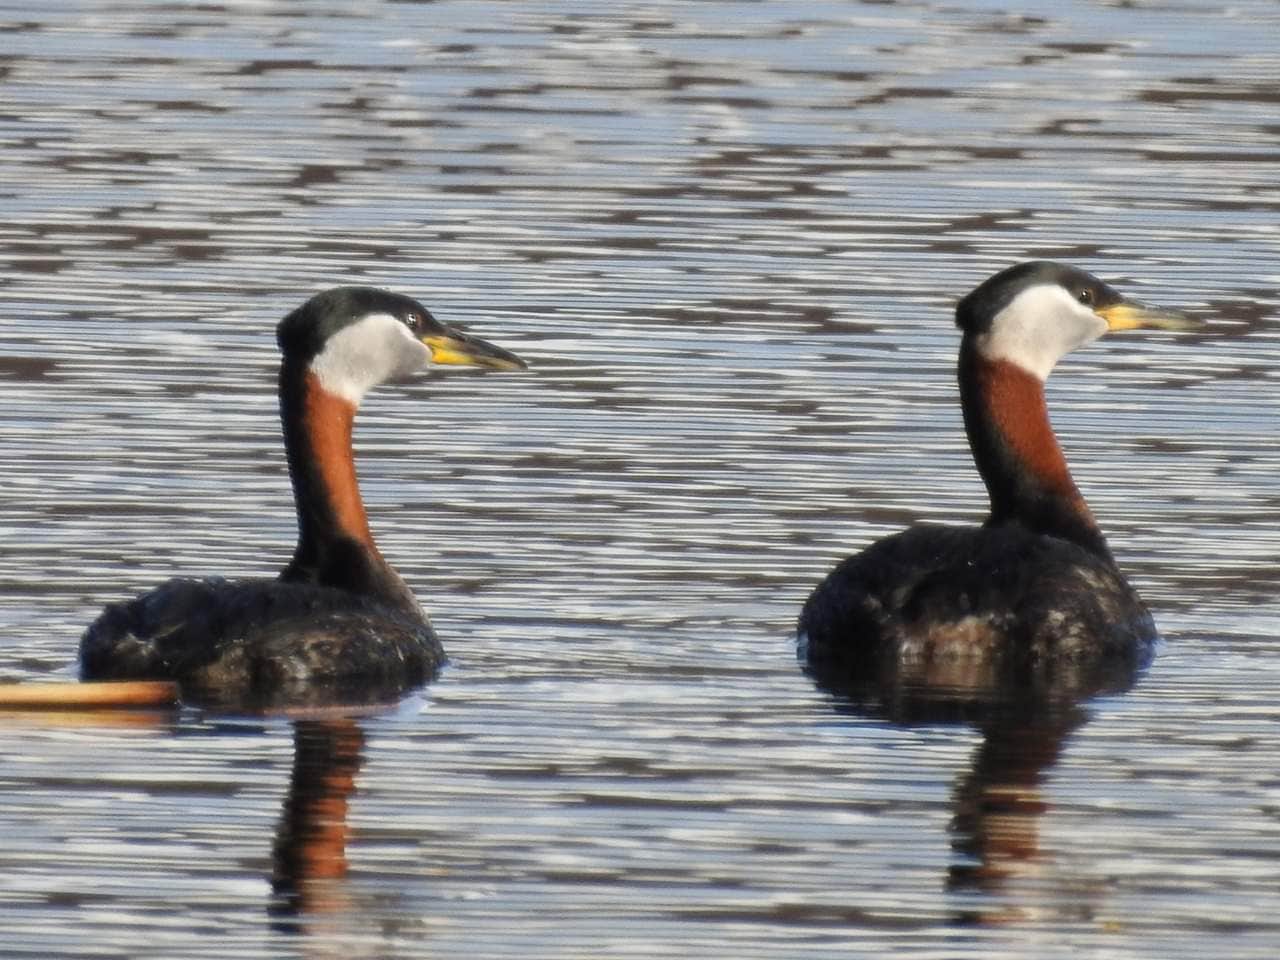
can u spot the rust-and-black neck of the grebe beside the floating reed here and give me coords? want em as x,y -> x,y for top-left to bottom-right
280,364 -> 416,609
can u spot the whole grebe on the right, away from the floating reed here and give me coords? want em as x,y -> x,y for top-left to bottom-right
797,261 -> 1190,689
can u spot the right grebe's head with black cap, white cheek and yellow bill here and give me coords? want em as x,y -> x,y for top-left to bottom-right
956,260 -> 1189,380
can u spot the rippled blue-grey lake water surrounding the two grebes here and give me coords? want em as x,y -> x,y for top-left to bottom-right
0,0 -> 1280,960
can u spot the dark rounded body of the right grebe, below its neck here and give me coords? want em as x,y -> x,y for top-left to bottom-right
797,524 -> 1157,681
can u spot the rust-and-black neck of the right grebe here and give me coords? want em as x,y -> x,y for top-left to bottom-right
960,340 -> 1111,559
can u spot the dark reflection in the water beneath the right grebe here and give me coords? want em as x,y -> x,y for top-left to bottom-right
808,647 -> 1147,925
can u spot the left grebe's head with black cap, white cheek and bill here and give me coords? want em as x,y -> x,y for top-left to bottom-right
275,287 -> 526,403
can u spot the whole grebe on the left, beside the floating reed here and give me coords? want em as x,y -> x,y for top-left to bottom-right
79,287 -> 525,705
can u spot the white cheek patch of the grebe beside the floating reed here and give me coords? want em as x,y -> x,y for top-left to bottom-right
311,314 -> 431,404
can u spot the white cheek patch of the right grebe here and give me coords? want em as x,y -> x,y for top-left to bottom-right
977,283 -> 1107,380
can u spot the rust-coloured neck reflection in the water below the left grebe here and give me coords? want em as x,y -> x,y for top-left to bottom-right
271,718 -> 365,919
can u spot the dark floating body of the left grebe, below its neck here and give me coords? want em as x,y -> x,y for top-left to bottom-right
81,577 -> 444,708
